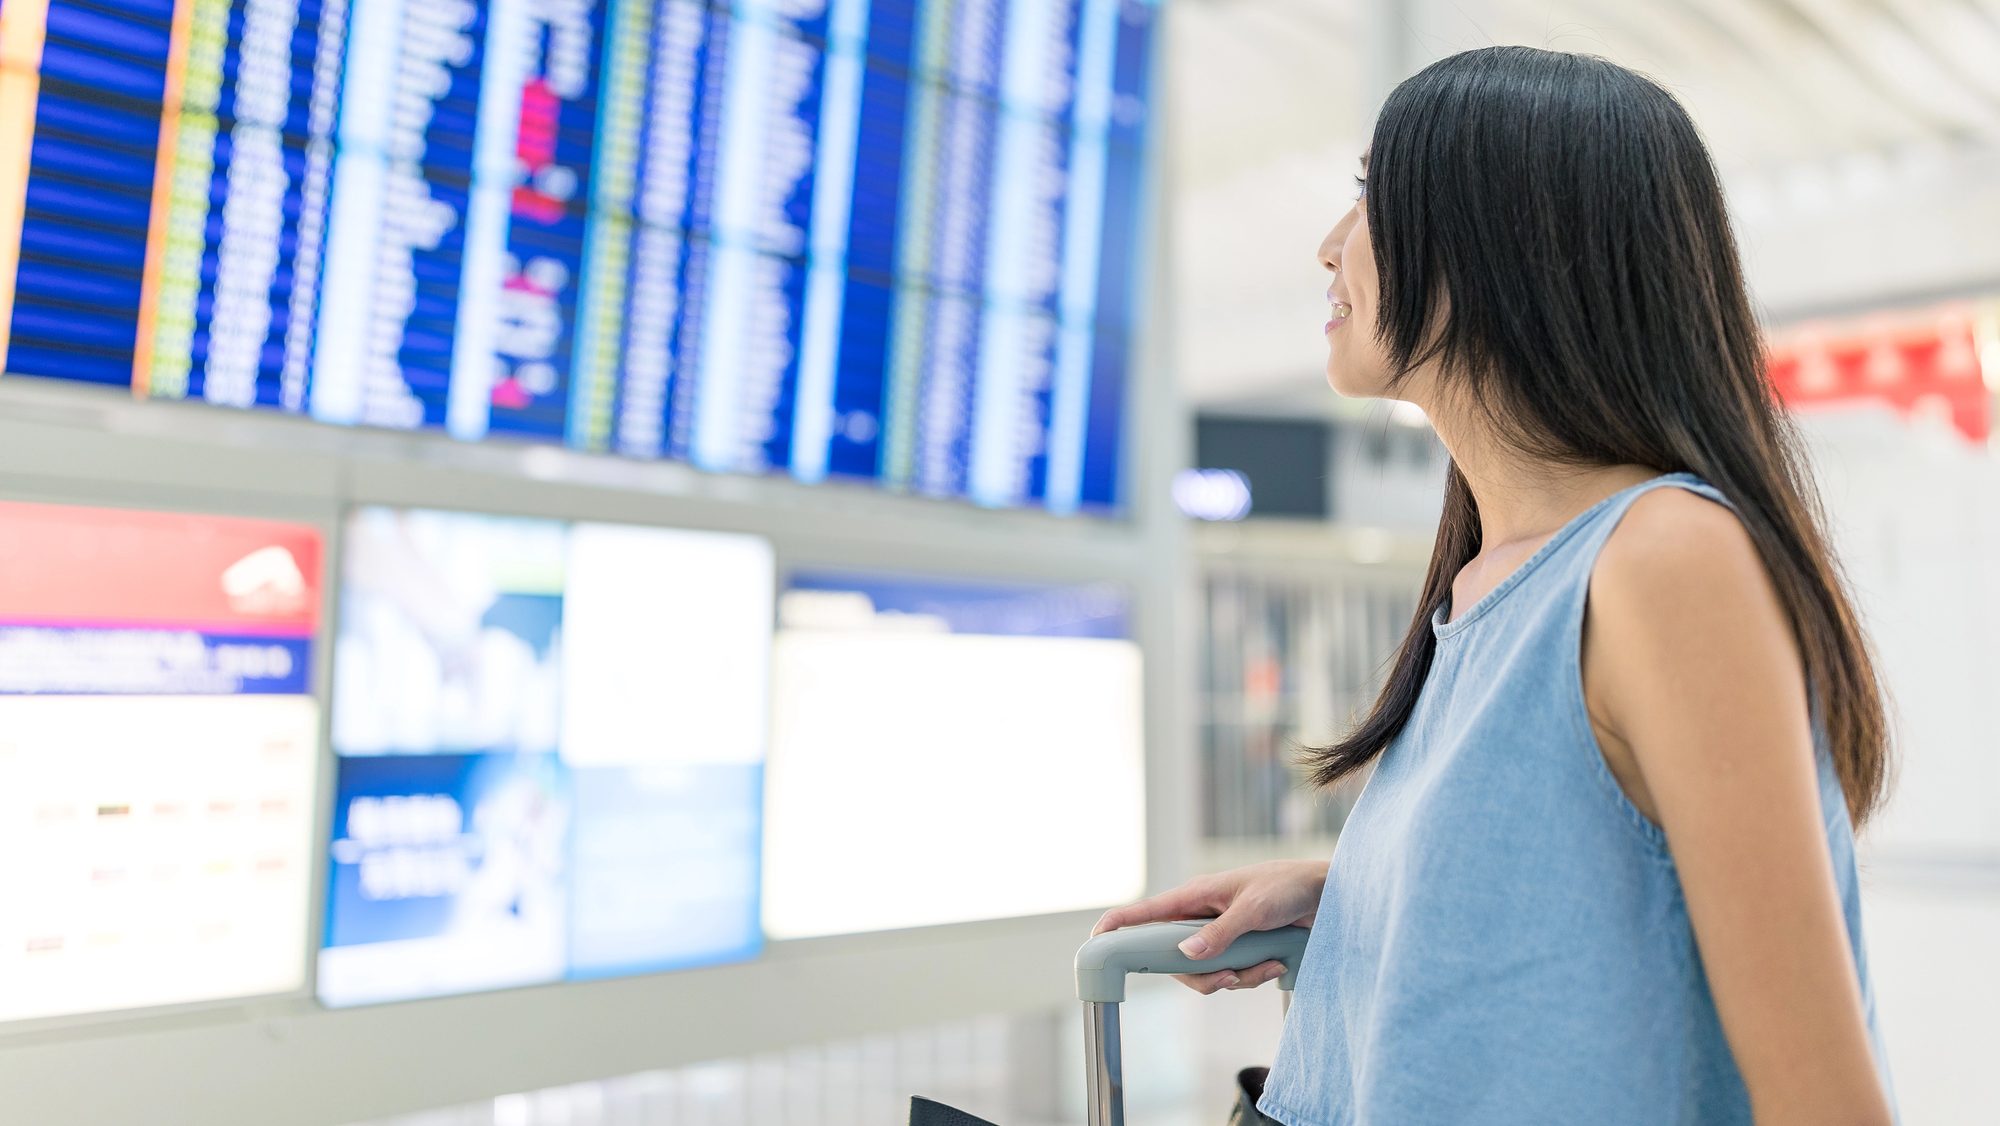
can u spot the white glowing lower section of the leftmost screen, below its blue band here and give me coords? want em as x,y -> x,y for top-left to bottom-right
0,696 -> 318,1020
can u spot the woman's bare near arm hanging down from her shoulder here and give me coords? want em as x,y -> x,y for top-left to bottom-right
1584,490 -> 1892,1126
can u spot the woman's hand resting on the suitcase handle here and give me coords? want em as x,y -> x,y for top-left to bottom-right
1090,860 -> 1326,994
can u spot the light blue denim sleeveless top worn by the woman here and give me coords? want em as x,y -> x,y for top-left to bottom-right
1258,474 -> 1888,1126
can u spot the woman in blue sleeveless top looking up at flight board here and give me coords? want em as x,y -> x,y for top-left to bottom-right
1098,48 -> 1892,1126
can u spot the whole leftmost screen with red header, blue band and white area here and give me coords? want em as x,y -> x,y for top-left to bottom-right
0,504 -> 322,1020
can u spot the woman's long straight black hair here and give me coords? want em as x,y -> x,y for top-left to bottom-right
1306,46 -> 1888,824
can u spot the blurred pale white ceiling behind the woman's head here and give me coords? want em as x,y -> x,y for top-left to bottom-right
1166,0 -> 2000,412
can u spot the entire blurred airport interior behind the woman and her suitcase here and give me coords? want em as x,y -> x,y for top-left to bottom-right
0,0 -> 2000,1126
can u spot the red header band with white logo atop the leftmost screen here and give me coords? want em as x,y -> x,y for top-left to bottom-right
0,502 -> 322,636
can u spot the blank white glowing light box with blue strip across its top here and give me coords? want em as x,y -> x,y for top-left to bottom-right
764,574 -> 1146,938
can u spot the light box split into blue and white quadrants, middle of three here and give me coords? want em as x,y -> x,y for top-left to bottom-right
318,508 -> 774,1006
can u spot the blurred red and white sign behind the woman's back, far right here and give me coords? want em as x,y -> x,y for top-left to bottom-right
1770,308 -> 2000,450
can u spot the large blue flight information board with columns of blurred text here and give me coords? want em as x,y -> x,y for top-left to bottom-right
0,0 -> 1154,512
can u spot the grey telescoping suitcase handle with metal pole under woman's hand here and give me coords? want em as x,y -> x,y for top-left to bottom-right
1076,918 -> 1310,1126
